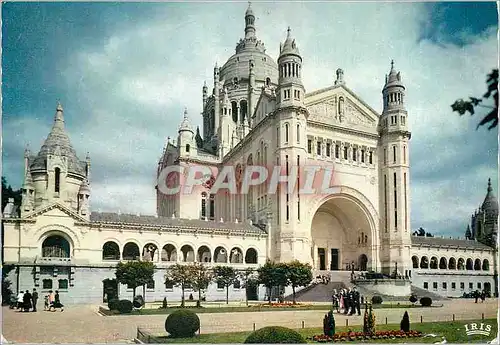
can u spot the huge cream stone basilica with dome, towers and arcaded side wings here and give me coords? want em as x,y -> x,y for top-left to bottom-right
2,6 -> 498,303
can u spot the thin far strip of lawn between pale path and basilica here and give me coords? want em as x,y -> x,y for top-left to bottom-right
99,303 -> 434,316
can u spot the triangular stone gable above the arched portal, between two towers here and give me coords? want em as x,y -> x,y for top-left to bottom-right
305,85 -> 379,130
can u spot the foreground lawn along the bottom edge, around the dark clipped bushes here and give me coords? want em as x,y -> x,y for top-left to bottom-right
140,319 -> 498,344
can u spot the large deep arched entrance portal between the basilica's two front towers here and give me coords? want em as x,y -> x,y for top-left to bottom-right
311,194 -> 374,271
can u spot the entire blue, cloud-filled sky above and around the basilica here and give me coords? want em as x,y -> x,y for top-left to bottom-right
2,2 -> 498,237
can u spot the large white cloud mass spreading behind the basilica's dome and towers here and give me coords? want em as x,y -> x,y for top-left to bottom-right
4,2 -> 498,235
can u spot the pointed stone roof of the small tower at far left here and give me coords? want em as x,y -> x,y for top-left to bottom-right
30,102 -> 85,175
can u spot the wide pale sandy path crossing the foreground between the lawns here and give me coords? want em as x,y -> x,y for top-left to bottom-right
2,299 -> 498,343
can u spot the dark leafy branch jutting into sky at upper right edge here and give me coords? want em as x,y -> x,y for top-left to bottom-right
451,69 -> 498,130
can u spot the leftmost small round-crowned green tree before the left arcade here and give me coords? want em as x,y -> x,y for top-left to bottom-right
115,261 -> 156,297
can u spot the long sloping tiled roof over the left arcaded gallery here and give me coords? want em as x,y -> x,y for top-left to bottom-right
90,212 -> 266,235
